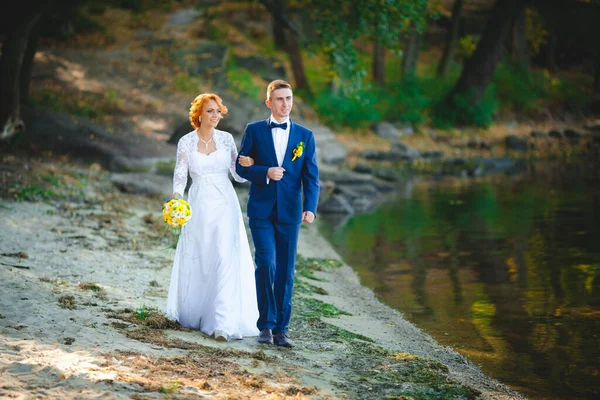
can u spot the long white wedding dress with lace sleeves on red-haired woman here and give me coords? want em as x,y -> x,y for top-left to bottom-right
167,129 -> 259,339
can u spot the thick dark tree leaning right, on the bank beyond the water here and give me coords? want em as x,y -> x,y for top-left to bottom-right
436,0 -> 527,124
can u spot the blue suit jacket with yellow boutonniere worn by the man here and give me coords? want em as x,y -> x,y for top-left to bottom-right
236,119 -> 319,224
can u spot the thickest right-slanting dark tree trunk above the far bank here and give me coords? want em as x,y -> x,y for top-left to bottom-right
446,0 -> 526,107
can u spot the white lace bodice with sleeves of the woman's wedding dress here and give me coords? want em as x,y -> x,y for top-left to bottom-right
173,129 -> 246,196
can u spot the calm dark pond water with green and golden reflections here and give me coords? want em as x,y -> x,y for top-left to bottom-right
321,163 -> 600,399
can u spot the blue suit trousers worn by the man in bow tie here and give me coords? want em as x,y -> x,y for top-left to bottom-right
249,208 -> 300,333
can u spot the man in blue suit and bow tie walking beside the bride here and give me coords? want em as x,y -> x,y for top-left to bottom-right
236,80 -> 319,347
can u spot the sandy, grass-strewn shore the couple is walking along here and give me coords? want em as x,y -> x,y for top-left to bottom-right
0,156 -> 522,399
